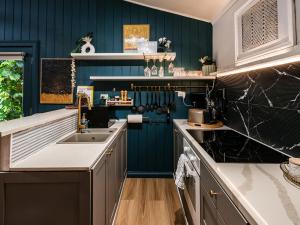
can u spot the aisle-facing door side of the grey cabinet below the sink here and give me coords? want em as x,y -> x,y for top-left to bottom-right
92,129 -> 127,225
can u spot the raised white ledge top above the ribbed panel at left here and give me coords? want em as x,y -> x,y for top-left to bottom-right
0,109 -> 77,137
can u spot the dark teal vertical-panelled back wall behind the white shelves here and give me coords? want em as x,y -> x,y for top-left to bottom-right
0,0 -> 212,176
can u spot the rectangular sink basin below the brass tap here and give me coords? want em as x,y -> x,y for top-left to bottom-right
58,128 -> 116,144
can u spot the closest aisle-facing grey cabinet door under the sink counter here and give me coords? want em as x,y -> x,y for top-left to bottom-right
93,157 -> 106,225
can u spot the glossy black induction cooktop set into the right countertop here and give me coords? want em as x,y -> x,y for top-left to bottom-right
187,130 -> 288,163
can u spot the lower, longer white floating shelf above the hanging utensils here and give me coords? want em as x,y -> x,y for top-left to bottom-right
90,76 -> 216,81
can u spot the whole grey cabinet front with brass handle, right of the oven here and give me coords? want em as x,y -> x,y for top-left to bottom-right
200,163 -> 249,225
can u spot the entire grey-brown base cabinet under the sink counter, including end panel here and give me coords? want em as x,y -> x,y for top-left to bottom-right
0,129 -> 127,225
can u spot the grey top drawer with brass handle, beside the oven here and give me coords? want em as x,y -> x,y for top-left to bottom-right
201,164 -> 248,225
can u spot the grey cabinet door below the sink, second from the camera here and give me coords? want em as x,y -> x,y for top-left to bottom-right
106,144 -> 117,224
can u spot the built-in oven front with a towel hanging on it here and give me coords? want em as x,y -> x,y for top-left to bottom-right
183,139 -> 200,225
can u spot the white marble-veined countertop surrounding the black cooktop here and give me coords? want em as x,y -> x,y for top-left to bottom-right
174,120 -> 300,225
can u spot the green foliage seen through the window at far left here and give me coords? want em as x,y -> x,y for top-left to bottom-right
0,60 -> 23,121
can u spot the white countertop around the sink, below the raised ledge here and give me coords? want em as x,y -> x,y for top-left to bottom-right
10,120 -> 127,171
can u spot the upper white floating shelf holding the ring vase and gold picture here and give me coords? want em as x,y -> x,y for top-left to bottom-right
71,52 -> 176,61
